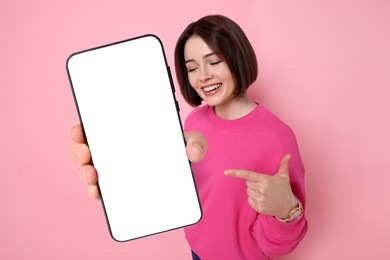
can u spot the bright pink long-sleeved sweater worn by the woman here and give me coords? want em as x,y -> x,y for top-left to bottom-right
185,105 -> 307,260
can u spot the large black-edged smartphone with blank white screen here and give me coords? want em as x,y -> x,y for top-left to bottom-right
66,35 -> 202,242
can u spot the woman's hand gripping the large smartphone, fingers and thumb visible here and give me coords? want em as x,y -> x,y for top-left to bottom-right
70,124 -> 207,199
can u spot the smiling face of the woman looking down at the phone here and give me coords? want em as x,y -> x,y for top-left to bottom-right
184,36 -> 235,106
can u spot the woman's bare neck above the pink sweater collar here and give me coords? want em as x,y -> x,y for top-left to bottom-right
214,96 -> 256,120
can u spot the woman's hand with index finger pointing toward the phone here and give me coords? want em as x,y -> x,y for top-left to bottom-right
224,154 -> 298,218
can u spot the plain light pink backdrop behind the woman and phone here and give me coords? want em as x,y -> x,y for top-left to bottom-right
0,0 -> 390,260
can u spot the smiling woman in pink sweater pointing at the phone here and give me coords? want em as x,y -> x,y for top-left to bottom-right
72,15 -> 307,260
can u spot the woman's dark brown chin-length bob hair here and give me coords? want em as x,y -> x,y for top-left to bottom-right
175,15 -> 257,107
